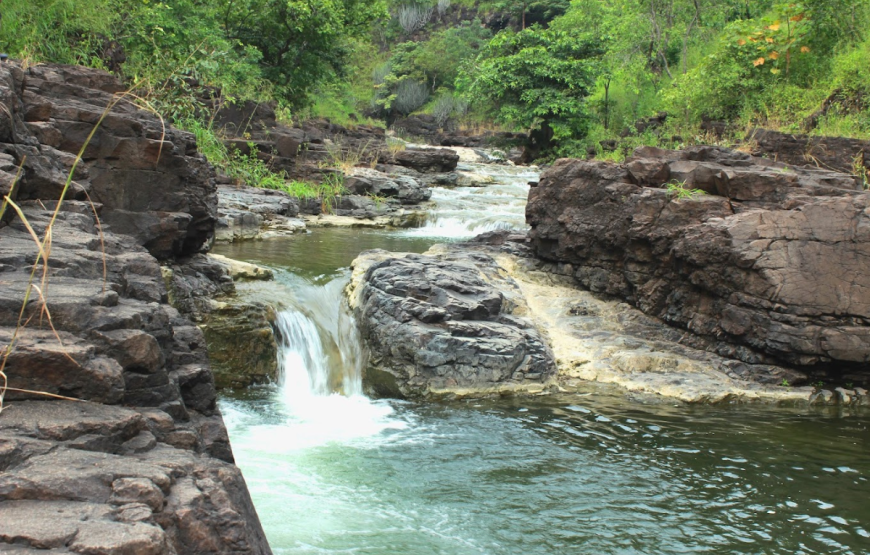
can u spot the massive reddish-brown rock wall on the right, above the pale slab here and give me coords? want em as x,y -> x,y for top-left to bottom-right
527,147 -> 870,383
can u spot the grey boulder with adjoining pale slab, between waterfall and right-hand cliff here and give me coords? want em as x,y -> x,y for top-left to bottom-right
347,232 -> 870,405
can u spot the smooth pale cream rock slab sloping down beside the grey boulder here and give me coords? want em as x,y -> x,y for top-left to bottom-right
495,254 -> 813,403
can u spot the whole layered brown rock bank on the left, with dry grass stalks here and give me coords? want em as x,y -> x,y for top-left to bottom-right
0,63 -> 270,554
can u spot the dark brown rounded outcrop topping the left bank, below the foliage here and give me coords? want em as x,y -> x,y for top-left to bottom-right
13,65 -> 217,259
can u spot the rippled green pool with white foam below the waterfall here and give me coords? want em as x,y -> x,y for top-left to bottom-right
222,390 -> 870,555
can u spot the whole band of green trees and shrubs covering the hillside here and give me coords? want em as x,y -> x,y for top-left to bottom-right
0,0 -> 870,161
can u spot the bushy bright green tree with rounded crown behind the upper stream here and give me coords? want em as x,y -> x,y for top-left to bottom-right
458,26 -> 601,146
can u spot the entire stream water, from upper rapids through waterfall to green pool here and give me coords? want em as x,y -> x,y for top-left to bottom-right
215,156 -> 870,555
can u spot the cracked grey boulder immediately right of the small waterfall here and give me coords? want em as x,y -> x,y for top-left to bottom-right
348,251 -> 555,397
